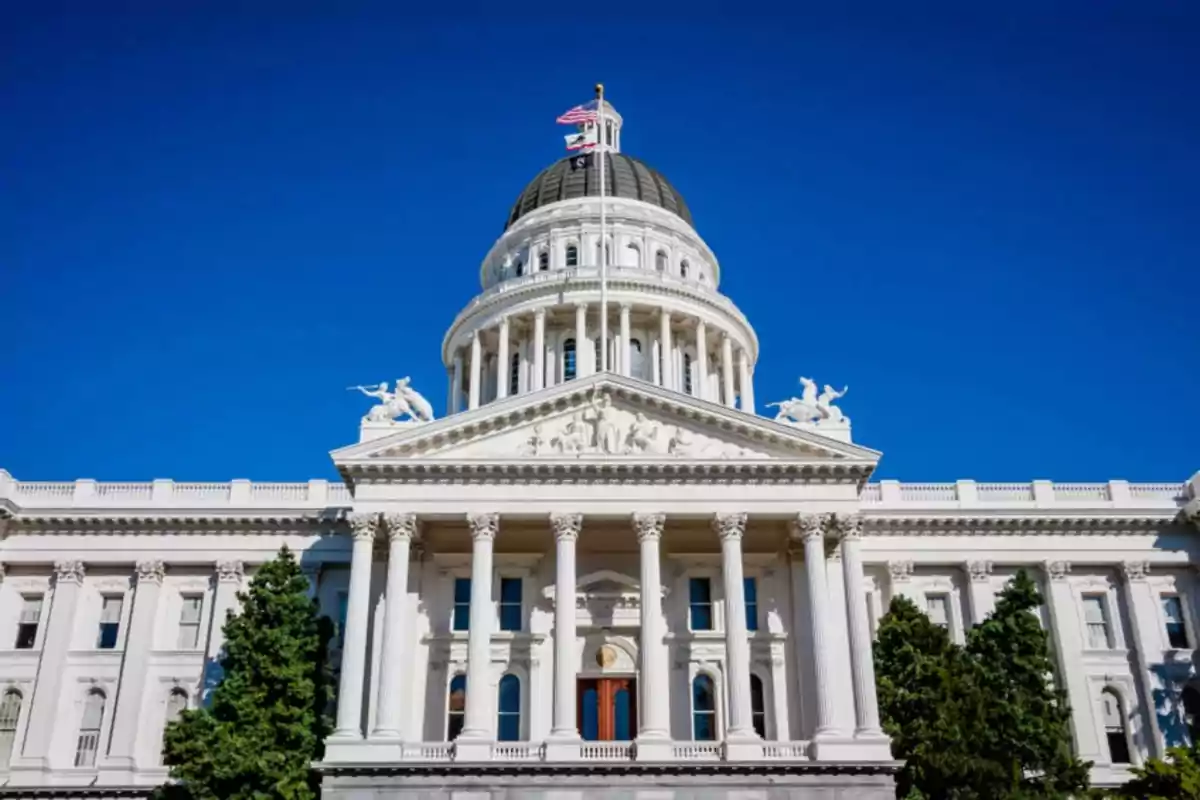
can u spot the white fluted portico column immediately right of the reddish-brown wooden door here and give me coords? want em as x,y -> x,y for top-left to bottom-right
634,513 -> 671,762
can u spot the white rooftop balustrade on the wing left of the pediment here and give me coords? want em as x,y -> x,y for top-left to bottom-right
0,470 -> 350,511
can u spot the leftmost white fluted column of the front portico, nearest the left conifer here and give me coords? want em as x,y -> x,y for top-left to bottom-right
331,513 -> 379,739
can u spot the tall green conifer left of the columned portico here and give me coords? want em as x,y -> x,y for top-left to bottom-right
156,547 -> 332,800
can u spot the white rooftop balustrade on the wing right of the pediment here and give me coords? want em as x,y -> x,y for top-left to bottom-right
862,481 -> 1189,510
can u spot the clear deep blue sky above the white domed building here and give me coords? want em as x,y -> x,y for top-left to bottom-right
0,1 -> 1200,481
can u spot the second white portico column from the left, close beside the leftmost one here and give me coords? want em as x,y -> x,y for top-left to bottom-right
371,513 -> 418,739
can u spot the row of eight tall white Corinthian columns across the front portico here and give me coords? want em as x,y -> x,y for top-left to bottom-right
334,512 -> 887,760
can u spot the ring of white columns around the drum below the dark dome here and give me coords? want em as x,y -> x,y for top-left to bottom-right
446,302 -> 755,414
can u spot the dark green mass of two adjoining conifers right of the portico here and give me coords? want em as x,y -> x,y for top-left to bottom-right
875,571 -> 1090,800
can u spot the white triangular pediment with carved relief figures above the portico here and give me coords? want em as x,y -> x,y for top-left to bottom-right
331,374 -> 880,471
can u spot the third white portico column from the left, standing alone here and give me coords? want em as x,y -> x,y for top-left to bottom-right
455,513 -> 500,760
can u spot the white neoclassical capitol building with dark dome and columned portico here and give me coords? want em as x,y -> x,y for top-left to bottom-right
0,106 -> 1200,800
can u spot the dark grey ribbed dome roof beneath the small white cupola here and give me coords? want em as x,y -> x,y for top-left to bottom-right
504,152 -> 692,230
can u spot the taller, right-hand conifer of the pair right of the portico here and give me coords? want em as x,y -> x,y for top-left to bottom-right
966,570 -> 1091,798
